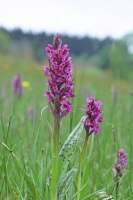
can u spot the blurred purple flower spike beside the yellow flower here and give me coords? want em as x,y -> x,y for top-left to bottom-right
13,74 -> 23,96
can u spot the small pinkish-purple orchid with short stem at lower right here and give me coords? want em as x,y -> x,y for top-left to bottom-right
114,149 -> 128,197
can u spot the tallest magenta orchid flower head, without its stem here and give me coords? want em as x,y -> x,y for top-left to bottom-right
44,34 -> 75,119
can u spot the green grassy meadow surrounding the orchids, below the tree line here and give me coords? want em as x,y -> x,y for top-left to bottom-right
0,52 -> 133,200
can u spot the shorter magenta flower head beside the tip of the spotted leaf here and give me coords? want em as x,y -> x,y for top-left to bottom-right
84,97 -> 103,135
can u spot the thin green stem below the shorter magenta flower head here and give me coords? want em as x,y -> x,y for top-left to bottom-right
77,133 -> 89,200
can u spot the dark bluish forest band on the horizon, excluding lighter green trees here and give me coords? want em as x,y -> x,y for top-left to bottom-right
0,29 -> 113,62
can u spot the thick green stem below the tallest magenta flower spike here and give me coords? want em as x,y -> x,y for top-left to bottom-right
50,118 -> 59,200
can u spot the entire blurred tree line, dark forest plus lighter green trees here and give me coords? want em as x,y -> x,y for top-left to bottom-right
0,27 -> 133,78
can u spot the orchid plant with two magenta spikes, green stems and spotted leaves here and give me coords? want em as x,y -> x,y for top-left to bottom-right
44,34 -> 103,200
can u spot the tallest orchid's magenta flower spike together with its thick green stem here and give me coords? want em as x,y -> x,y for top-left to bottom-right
44,34 -> 75,200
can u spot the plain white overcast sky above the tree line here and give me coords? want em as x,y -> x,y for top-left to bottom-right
0,0 -> 133,38
